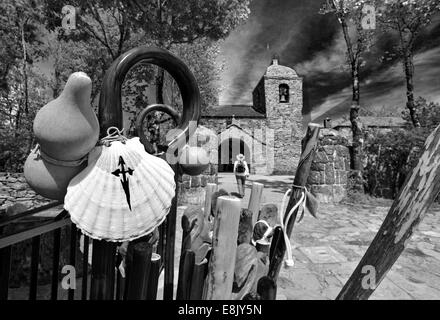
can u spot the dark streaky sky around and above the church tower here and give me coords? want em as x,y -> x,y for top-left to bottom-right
220,0 -> 440,119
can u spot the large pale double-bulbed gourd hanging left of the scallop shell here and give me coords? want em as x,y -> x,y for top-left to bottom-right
24,72 -> 99,200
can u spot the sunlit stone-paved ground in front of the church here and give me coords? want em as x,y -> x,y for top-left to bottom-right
219,174 -> 440,300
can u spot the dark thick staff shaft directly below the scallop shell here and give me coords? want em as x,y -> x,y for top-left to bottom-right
90,240 -> 116,300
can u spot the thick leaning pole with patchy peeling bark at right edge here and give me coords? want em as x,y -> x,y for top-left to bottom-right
337,126 -> 440,300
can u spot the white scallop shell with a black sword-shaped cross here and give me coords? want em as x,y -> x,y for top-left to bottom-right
64,138 -> 175,242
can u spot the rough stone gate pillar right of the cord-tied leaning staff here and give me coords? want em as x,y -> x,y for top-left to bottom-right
307,129 -> 350,203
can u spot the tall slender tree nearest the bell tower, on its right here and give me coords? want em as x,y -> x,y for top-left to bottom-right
320,0 -> 374,177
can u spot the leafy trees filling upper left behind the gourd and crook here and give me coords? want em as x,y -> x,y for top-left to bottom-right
0,0 -> 249,171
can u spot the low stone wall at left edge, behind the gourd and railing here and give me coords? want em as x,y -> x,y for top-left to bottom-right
0,172 -> 53,211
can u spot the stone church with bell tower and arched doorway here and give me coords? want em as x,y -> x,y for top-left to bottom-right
200,58 -> 305,175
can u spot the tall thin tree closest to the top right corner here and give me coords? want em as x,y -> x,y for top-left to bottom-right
378,0 -> 440,127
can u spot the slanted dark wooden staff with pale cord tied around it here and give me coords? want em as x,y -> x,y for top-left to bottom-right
268,123 -> 320,283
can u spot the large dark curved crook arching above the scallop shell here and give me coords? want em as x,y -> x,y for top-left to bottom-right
98,46 -> 200,161
